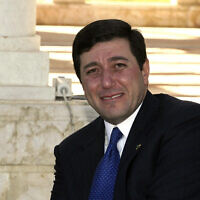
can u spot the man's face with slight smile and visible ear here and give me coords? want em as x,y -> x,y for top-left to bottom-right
80,38 -> 149,124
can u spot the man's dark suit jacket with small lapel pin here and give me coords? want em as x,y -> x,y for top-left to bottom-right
51,92 -> 200,200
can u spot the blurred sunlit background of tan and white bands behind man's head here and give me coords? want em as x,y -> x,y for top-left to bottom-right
37,0 -> 200,101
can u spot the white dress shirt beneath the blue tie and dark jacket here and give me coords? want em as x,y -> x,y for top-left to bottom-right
104,104 -> 142,157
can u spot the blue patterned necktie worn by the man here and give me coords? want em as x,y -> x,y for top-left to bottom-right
89,127 -> 122,200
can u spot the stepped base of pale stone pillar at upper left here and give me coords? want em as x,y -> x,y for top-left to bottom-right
0,0 -> 54,100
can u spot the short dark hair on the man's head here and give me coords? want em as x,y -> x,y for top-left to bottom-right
72,19 -> 147,81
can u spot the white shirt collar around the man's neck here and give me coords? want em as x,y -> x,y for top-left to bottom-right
104,103 -> 142,141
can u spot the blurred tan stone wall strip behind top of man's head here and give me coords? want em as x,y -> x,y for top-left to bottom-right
37,0 -> 200,27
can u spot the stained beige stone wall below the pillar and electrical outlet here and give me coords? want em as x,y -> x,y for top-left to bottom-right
0,101 -> 97,200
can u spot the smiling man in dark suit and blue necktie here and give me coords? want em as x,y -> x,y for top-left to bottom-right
51,20 -> 200,200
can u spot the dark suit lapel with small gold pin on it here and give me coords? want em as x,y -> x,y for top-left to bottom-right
115,92 -> 159,199
